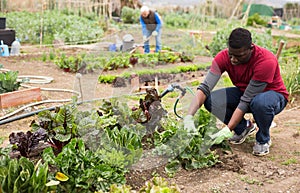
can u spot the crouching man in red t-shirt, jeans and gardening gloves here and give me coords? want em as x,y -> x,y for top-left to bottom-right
184,28 -> 289,156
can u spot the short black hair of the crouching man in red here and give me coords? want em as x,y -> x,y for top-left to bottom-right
228,28 -> 252,49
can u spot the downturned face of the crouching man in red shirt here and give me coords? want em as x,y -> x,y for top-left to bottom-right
228,46 -> 253,65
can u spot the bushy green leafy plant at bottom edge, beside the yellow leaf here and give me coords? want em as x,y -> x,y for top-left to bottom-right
43,138 -> 126,192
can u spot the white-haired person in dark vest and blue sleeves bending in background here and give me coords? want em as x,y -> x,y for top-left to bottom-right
140,6 -> 162,53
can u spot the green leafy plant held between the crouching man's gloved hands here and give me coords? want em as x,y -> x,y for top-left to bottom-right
154,109 -> 218,176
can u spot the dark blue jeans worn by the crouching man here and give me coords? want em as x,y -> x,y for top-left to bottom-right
204,87 -> 287,144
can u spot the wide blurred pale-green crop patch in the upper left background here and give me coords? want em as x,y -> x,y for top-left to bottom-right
0,10 -> 104,44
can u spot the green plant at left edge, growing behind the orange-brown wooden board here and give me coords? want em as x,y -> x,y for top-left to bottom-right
0,71 -> 21,94
